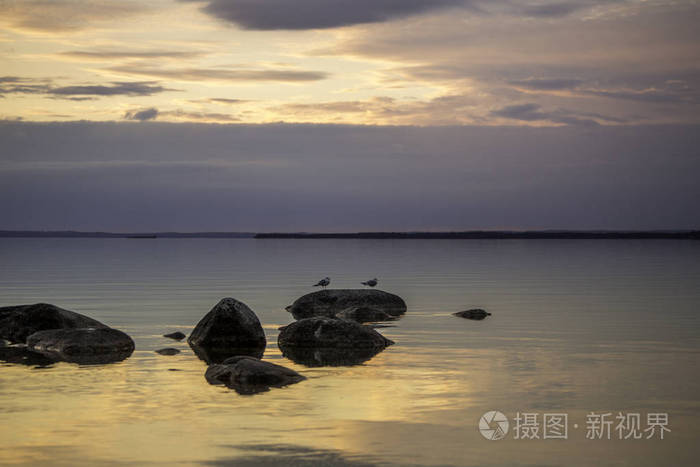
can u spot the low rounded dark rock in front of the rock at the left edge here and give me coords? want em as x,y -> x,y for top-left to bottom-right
27,328 -> 134,364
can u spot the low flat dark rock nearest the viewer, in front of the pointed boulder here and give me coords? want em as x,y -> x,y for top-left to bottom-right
204,356 -> 306,394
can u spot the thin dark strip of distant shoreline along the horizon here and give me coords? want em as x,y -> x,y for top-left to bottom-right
0,230 -> 700,240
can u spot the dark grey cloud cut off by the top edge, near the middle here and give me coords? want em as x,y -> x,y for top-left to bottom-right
186,0 -> 465,30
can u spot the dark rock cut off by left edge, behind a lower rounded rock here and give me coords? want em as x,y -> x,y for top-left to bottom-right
0,303 -> 108,344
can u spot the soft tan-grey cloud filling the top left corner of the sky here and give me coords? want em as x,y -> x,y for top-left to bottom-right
0,0 -> 149,32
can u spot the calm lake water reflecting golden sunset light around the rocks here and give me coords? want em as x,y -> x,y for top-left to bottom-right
0,239 -> 700,467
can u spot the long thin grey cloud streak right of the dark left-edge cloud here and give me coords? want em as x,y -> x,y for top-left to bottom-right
109,64 -> 329,83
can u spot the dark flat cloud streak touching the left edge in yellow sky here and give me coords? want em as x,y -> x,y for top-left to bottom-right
0,76 -> 176,101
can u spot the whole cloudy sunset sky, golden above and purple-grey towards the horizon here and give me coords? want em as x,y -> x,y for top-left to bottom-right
0,0 -> 700,231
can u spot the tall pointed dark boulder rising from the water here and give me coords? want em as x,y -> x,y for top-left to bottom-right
187,298 -> 267,363
